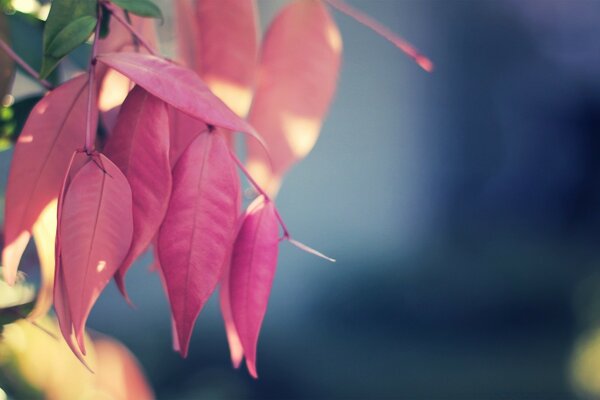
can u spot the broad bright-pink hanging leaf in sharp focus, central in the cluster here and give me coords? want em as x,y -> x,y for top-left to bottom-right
157,133 -> 239,356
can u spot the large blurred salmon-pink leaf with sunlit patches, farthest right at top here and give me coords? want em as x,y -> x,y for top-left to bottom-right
248,0 -> 342,195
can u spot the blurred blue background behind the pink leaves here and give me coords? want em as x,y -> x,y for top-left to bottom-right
5,0 -> 600,399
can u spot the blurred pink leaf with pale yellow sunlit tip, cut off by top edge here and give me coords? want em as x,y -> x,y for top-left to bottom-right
192,0 -> 258,117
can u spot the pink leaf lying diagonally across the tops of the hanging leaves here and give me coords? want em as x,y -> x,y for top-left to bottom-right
98,53 -> 258,138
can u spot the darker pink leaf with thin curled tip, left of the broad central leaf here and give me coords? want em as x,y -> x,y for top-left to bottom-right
104,86 -> 171,298
